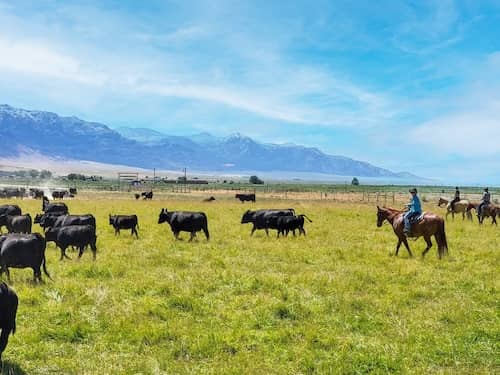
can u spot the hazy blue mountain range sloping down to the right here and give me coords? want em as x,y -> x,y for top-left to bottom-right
0,104 -> 418,179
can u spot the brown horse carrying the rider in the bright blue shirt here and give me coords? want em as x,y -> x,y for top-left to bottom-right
377,206 -> 448,259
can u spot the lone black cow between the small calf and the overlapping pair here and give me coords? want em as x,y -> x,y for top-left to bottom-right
158,208 -> 210,241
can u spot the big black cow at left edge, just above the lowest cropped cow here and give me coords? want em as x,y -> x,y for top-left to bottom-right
0,233 -> 50,282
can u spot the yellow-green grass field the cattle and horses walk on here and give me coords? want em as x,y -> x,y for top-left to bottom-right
3,199 -> 500,374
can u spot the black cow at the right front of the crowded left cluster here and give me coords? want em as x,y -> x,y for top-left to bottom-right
45,225 -> 97,260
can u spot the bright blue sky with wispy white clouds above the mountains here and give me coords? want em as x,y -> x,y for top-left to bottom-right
0,0 -> 500,185
